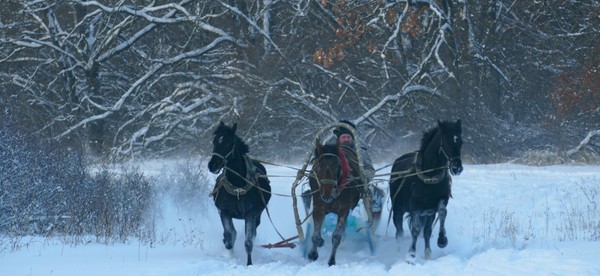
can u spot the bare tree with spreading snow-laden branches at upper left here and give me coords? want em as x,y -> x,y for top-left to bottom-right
3,0 -> 253,157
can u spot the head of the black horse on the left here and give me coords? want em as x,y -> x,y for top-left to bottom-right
208,122 -> 237,173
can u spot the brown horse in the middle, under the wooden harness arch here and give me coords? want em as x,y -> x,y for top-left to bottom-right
308,141 -> 363,266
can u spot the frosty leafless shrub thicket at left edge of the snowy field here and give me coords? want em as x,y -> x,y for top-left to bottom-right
0,121 -> 154,241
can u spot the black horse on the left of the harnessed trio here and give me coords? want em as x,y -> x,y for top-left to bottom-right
208,122 -> 271,265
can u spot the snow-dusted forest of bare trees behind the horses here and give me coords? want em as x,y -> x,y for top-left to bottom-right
0,0 -> 600,163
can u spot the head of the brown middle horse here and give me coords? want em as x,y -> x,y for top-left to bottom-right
311,140 -> 342,203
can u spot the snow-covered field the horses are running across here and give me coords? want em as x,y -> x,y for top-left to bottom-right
0,163 -> 600,276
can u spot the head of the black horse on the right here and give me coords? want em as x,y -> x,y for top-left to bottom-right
438,119 -> 463,175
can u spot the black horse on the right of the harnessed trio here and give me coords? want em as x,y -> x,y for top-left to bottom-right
390,119 -> 463,263
